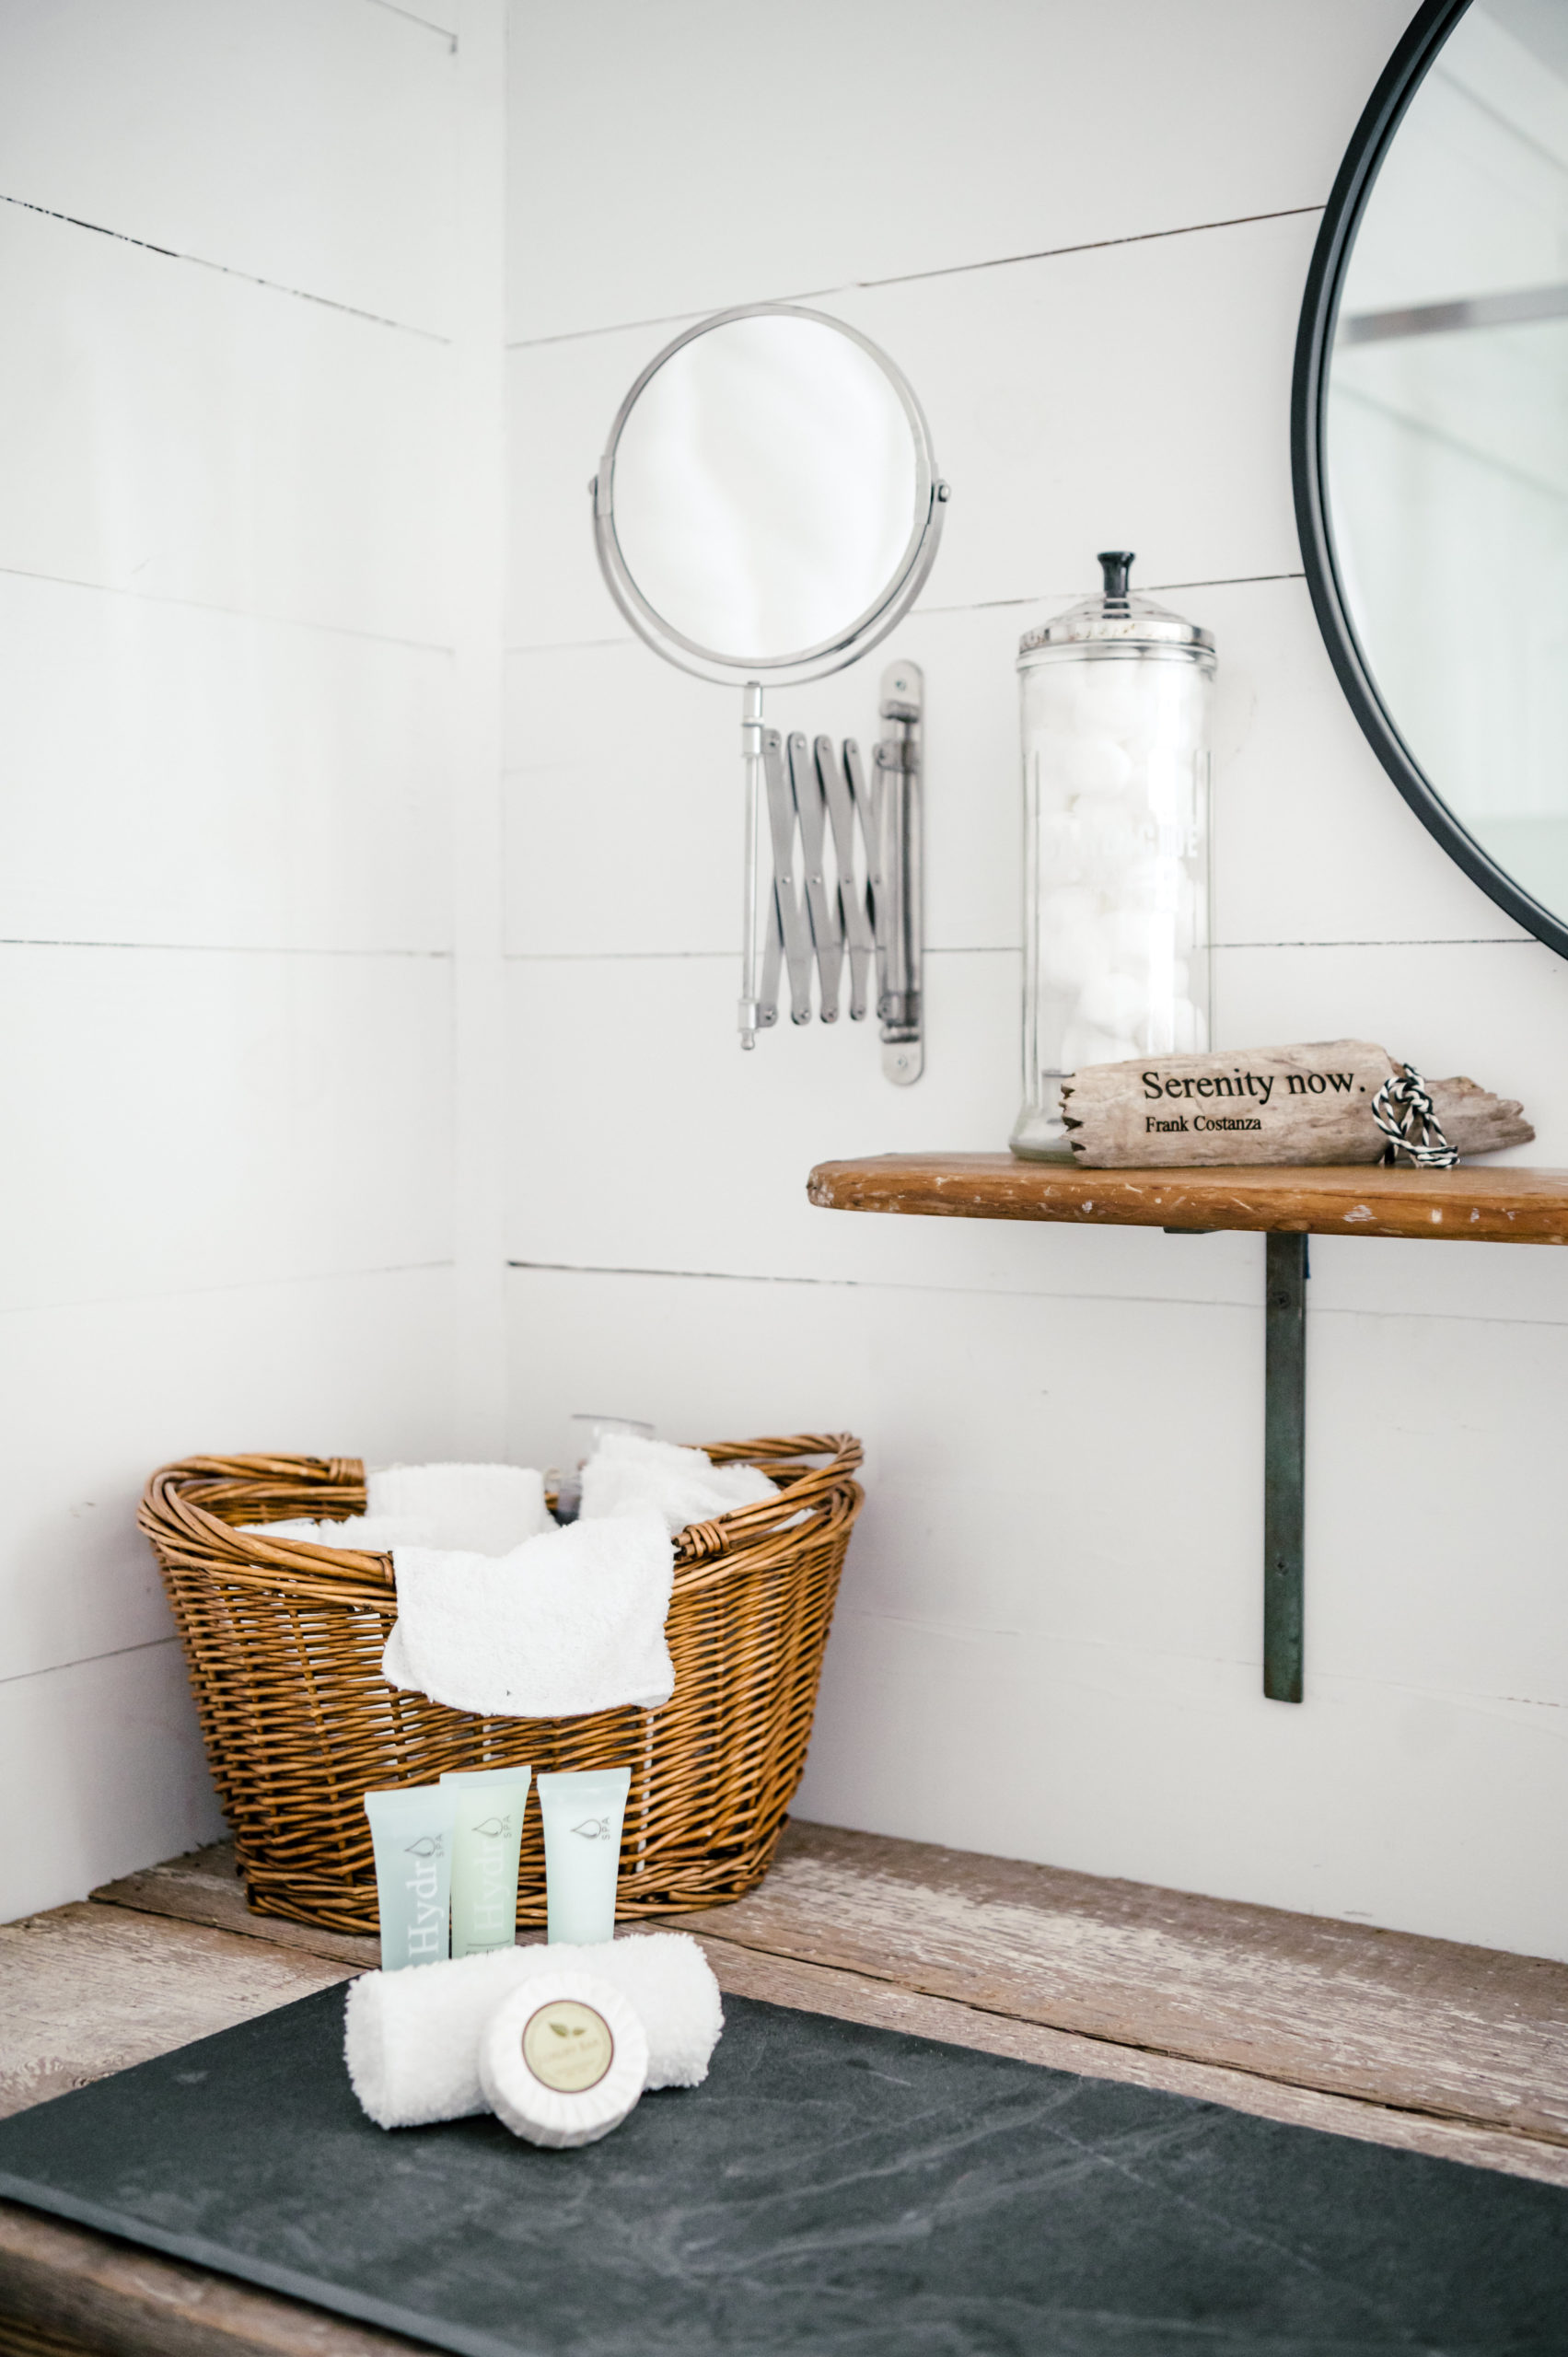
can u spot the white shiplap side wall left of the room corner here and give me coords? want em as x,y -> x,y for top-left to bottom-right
0,0 -> 502,1916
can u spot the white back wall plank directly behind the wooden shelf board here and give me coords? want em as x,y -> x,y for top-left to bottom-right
507,946 -> 1568,1325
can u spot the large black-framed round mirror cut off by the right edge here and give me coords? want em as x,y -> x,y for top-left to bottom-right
1295,0 -> 1568,955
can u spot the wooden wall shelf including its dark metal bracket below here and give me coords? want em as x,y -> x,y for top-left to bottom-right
807,1155 -> 1568,1701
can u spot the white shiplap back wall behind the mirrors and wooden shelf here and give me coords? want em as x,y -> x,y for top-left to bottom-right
505,0 -> 1568,1956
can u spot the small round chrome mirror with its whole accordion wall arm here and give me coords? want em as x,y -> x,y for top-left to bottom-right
592,304 -> 947,1082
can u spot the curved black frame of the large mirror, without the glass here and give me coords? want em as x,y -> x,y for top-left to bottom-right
1290,0 -> 1568,957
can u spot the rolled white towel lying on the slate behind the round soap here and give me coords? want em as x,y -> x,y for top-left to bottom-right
344,1931 -> 724,2129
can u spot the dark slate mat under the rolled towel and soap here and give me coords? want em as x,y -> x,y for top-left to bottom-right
0,1990 -> 1568,2357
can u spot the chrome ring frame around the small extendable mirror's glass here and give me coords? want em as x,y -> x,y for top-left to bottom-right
589,302 -> 947,689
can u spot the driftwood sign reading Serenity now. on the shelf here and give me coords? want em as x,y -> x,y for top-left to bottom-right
1061,1039 -> 1535,1169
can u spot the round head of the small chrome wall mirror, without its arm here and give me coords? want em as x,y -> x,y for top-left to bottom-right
594,304 -> 946,683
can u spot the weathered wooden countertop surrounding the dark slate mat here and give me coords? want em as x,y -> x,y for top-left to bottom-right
0,1824 -> 1568,2357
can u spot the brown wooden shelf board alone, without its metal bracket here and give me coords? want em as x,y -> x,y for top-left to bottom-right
807,1155 -> 1568,1245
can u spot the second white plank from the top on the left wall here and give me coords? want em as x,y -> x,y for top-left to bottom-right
0,203 -> 455,644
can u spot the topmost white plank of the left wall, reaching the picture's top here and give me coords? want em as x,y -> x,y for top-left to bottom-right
0,0 -> 458,330
